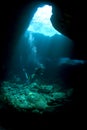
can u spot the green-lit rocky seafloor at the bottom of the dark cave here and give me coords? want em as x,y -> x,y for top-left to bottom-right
0,80 -> 74,114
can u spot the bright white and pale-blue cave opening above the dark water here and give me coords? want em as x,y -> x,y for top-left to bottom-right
27,5 -> 61,37
